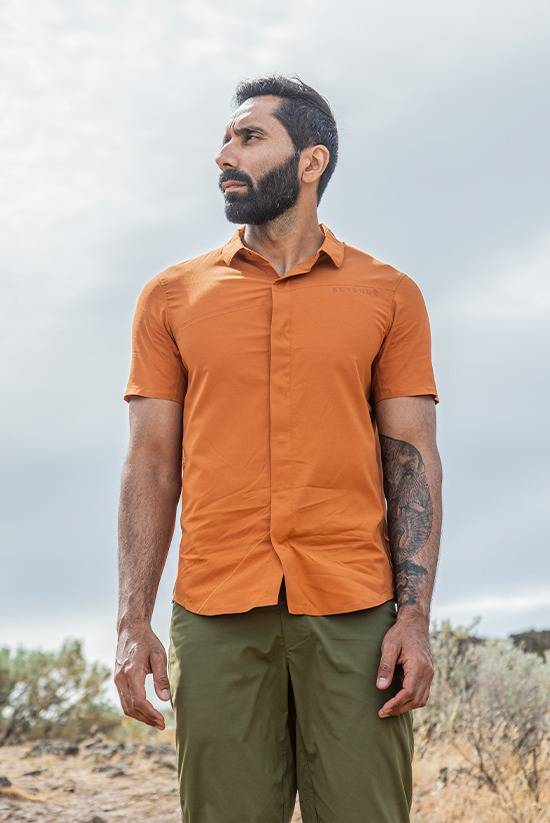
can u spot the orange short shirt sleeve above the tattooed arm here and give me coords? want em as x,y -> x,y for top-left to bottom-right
371,274 -> 439,403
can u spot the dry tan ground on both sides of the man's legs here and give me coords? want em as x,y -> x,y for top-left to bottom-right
0,730 -> 550,823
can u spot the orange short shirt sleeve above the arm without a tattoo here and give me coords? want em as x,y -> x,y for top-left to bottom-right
124,275 -> 187,403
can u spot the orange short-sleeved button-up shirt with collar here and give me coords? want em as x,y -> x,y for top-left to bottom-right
124,223 -> 439,615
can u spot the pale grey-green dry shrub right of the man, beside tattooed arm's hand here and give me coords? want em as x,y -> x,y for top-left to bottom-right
415,621 -> 550,821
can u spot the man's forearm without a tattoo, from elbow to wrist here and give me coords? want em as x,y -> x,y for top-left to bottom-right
117,458 -> 181,631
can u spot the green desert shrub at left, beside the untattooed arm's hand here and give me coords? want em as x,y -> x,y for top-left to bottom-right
0,640 -> 121,745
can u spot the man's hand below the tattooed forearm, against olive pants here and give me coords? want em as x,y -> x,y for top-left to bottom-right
376,615 -> 434,717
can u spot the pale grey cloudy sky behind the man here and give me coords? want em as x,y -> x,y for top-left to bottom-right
0,0 -> 550,700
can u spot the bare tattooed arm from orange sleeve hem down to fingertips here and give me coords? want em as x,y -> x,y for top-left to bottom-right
376,395 -> 442,714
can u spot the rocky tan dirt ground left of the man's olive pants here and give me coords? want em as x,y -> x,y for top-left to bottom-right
0,733 -> 301,823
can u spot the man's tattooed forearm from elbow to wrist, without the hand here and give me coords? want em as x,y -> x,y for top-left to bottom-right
380,435 -> 442,625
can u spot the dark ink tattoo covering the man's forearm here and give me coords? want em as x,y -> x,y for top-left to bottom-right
380,435 -> 433,608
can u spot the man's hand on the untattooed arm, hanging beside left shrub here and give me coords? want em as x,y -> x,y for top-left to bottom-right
114,623 -> 171,729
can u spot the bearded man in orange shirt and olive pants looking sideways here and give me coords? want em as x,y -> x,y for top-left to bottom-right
115,75 -> 442,823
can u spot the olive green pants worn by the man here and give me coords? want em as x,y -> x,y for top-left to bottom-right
168,580 -> 414,823
